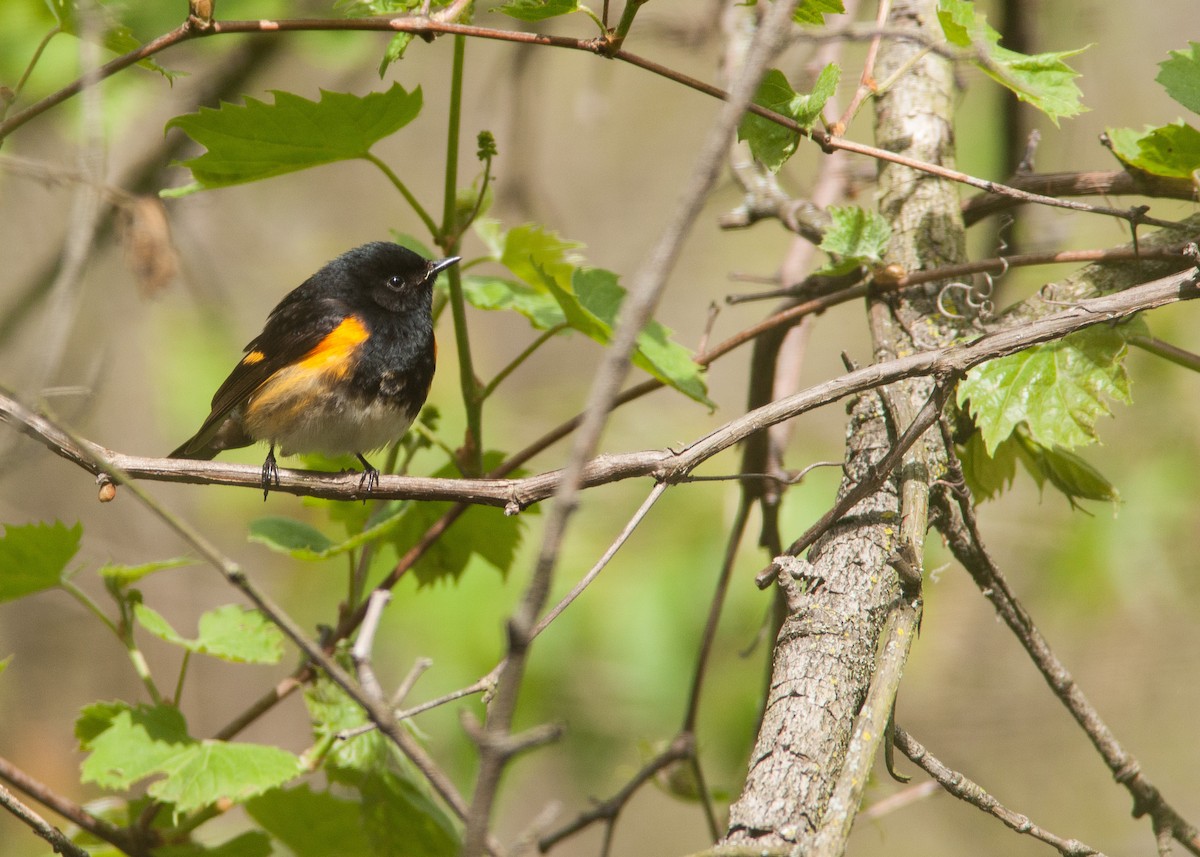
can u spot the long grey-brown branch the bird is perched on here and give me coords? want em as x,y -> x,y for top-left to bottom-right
0,269 -> 1200,504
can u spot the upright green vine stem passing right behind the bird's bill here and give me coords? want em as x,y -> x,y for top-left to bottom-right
438,35 -> 484,475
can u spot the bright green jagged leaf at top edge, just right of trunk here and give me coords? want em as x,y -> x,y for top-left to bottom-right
937,0 -> 1087,125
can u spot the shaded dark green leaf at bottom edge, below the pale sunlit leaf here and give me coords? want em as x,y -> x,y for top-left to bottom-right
246,785 -> 369,857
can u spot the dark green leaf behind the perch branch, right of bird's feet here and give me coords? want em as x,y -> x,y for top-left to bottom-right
389,450 -> 533,585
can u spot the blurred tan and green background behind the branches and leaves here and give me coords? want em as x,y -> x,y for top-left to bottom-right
0,0 -> 1200,857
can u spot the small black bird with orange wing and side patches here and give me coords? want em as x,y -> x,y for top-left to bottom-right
170,241 -> 458,498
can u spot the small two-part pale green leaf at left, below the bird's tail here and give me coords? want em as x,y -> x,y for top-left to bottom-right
133,604 -> 283,664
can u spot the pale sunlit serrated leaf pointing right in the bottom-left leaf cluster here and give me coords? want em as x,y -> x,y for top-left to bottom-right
146,741 -> 304,814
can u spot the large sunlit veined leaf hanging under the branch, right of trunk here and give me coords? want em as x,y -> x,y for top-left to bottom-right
958,322 -> 1145,455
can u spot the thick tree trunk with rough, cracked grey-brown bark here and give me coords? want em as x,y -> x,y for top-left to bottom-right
725,0 -> 964,853
